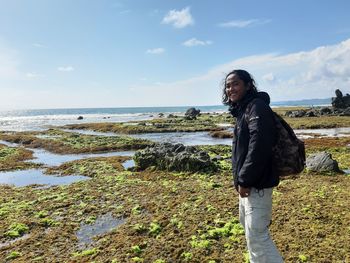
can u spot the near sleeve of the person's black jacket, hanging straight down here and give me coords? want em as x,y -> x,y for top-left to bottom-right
238,100 -> 275,187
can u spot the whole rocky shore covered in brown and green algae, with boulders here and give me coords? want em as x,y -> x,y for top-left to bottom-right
0,106 -> 350,263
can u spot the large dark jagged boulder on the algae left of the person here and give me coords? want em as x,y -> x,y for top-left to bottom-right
134,143 -> 216,172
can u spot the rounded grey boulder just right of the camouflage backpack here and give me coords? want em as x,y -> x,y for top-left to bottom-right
306,152 -> 342,173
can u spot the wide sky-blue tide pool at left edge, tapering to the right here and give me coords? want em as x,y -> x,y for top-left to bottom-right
0,169 -> 90,187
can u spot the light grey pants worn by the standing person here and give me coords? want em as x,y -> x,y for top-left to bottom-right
239,188 -> 283,263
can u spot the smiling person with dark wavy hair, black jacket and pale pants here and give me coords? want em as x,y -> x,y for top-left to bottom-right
223,70 -> 283,263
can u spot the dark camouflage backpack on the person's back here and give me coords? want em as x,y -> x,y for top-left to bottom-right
245,103 -> 306,177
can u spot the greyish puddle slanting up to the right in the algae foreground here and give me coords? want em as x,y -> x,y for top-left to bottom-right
76,213 -> 126,248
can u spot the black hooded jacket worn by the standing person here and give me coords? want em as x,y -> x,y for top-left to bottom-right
230,92 -> 279,189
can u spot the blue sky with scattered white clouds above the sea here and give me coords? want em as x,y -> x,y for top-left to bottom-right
0,0 -> 350,110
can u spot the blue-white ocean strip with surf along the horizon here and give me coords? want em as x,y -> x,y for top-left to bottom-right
0,101 -> 330,131
